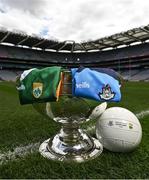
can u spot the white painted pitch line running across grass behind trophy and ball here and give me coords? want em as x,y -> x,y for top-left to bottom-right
0,110 -> 149,165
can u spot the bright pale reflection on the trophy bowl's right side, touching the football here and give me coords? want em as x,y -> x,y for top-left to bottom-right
89,102 -> 107,119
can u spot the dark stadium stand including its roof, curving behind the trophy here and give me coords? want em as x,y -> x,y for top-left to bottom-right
0,25 -> 149,81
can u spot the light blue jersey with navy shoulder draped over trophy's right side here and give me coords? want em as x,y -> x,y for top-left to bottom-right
71,68 -> 121,102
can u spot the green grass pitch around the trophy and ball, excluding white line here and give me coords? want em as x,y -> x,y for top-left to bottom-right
0,82 -> 149,179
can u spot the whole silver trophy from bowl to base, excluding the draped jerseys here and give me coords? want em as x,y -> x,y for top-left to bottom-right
33,72 -> 103,162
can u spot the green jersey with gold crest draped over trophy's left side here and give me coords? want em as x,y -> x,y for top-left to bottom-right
17,66 -> 61,104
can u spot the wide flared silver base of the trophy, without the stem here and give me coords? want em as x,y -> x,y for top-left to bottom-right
39,135 -> 103,162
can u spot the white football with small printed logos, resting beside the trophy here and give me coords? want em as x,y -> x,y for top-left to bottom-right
96,107 -> 142,152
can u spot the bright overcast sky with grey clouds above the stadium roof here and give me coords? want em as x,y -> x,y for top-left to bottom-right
0,0 -> 149,41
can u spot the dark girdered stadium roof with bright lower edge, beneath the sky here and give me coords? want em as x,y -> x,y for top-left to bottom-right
0,25 -> 149,53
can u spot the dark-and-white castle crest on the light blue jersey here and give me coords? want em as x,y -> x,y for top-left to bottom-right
98,84 -> 115,100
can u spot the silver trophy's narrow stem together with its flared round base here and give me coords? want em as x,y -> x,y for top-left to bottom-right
39,119 -> 103,162
